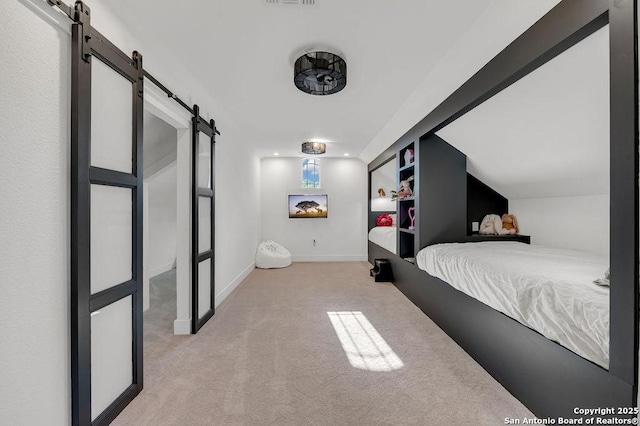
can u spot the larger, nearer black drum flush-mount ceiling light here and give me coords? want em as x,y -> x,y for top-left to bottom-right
293,52 -> 347,95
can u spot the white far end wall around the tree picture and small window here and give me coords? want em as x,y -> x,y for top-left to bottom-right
261,158 -> 368,261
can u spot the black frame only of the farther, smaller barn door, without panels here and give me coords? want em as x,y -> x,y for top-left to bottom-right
191,105 -> 216,334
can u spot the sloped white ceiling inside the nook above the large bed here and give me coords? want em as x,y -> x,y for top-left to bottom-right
437,26 -> 609,199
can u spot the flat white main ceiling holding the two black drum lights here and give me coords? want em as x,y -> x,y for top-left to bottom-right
105,0 -> 491,157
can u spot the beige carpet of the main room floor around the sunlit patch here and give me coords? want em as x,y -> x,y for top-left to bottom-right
113,262 -> 532,425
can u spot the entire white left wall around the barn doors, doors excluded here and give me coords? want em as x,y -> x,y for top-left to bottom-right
0,0 -> 260,425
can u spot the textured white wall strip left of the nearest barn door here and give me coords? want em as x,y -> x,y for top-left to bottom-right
0,1 -> 71,425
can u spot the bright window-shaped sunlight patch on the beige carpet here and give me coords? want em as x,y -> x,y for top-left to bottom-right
327,311 -> 404,371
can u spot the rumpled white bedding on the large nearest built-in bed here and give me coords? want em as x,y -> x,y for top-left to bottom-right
416,241 -> 609,368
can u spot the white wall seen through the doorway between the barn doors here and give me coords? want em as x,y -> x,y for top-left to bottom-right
148,167 -> 177,277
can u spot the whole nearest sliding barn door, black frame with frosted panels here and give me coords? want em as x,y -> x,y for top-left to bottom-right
71,3 -> 143,425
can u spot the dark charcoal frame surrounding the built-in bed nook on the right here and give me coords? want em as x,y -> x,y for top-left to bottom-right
368,0 -> 639,418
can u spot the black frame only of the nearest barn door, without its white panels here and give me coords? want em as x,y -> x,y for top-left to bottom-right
71,2 -> 143,425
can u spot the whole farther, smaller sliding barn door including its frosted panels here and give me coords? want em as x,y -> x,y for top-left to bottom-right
191,105 -> 215,334
